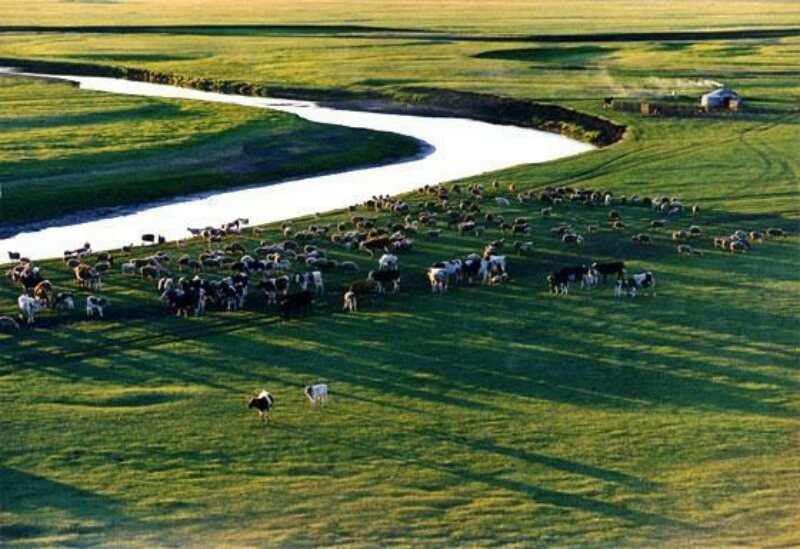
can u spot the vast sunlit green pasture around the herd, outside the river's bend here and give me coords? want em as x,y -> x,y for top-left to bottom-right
0,0 -> 800,546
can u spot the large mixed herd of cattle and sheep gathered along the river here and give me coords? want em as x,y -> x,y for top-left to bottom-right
0,182 -> 785,332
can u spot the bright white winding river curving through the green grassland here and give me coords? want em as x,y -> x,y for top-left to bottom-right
0,69 -> 594,263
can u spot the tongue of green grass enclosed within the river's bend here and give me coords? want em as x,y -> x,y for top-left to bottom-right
0,77 -> 418,225
